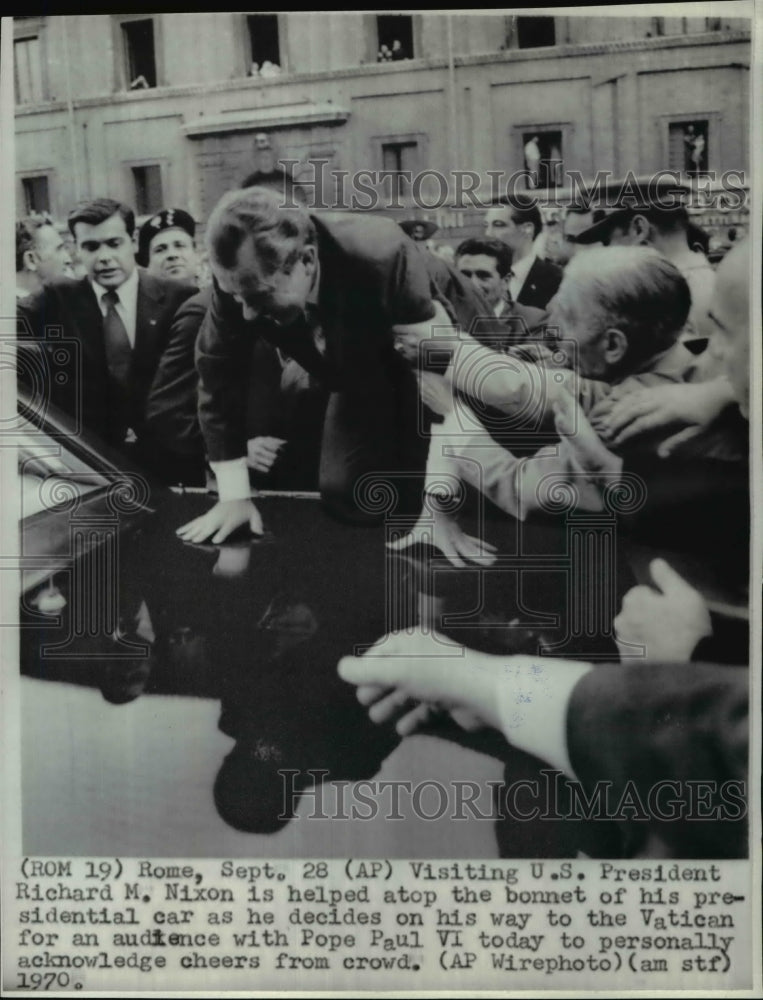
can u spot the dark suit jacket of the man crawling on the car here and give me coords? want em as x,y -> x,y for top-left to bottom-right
196,212 -> 496,462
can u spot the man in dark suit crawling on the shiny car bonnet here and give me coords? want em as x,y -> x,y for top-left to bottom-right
180,188 -> 502,541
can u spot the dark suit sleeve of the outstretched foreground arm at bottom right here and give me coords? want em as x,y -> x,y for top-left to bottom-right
567,663 -> 749,857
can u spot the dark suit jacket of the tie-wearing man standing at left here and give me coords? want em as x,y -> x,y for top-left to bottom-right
19,269 -> 196,447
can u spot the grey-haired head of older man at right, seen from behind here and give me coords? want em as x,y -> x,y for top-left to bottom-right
549,247 -> 691,381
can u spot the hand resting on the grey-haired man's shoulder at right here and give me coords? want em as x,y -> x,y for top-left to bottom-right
591,378 -> 733,454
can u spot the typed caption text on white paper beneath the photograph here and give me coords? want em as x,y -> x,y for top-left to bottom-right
3,858 -> 752,995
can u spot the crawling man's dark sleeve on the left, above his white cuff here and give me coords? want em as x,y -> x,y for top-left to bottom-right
195,284 -> 254,462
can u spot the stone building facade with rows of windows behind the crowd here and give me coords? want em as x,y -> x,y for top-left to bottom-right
14,14 -> 751,240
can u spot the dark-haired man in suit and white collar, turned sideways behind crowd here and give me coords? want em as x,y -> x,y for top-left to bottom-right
485,195 -> 562,309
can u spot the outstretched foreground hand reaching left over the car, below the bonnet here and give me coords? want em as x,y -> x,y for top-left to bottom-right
339,629 -> 501,736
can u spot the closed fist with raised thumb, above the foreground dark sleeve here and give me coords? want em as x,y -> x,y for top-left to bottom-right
614,559 -> 713,663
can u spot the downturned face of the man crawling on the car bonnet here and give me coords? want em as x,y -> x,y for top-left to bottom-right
212,237 -> 317,325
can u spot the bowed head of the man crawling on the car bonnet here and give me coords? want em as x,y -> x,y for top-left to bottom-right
206,187 -> 318,324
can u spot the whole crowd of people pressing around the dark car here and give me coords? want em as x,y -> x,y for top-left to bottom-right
16,168 -> 750,857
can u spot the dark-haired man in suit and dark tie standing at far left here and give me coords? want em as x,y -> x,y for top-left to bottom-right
19,198 -> 195,469
